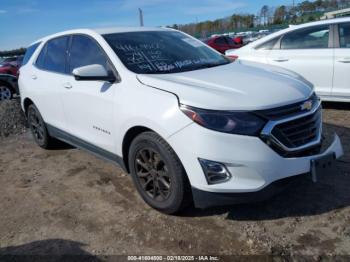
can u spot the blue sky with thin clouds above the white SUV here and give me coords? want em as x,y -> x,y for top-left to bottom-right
0,0 -> 300,50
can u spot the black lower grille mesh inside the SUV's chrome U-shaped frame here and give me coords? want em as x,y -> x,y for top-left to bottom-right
271,109 -> 322,149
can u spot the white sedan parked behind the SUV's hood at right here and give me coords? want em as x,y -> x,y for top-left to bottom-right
226,18 -> 350,102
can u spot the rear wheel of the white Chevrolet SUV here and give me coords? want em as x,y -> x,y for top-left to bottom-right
27,104 -> 56,149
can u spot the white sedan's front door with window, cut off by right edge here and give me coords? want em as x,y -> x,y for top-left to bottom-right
332,23 -> 350,99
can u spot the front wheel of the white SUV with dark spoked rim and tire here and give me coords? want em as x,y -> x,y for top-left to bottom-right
128,132 -> 192,214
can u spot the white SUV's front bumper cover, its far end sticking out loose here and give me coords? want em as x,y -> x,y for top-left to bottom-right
168,123 -> 343,200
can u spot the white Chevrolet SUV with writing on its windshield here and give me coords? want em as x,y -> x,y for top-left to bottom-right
19,28 -> 343,213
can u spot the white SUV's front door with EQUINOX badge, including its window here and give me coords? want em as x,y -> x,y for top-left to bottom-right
63,35 -> 117,152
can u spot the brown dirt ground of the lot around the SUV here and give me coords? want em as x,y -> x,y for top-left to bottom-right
0,100 -> 350,257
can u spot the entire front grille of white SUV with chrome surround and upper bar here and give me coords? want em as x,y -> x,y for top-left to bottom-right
256,94 -> 322,157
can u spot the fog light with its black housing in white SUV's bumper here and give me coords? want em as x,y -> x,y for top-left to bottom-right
198,158 -> 232,185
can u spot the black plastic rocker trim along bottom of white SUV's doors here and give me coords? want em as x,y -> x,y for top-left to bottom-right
46,124 -> 128,173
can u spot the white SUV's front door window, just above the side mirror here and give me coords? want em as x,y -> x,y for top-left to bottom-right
69,35 -> 108,73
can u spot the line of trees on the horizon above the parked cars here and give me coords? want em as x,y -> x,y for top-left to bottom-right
170,0 -> 350,37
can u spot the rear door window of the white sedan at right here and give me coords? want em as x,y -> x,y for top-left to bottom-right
281,25 -> 329,49
